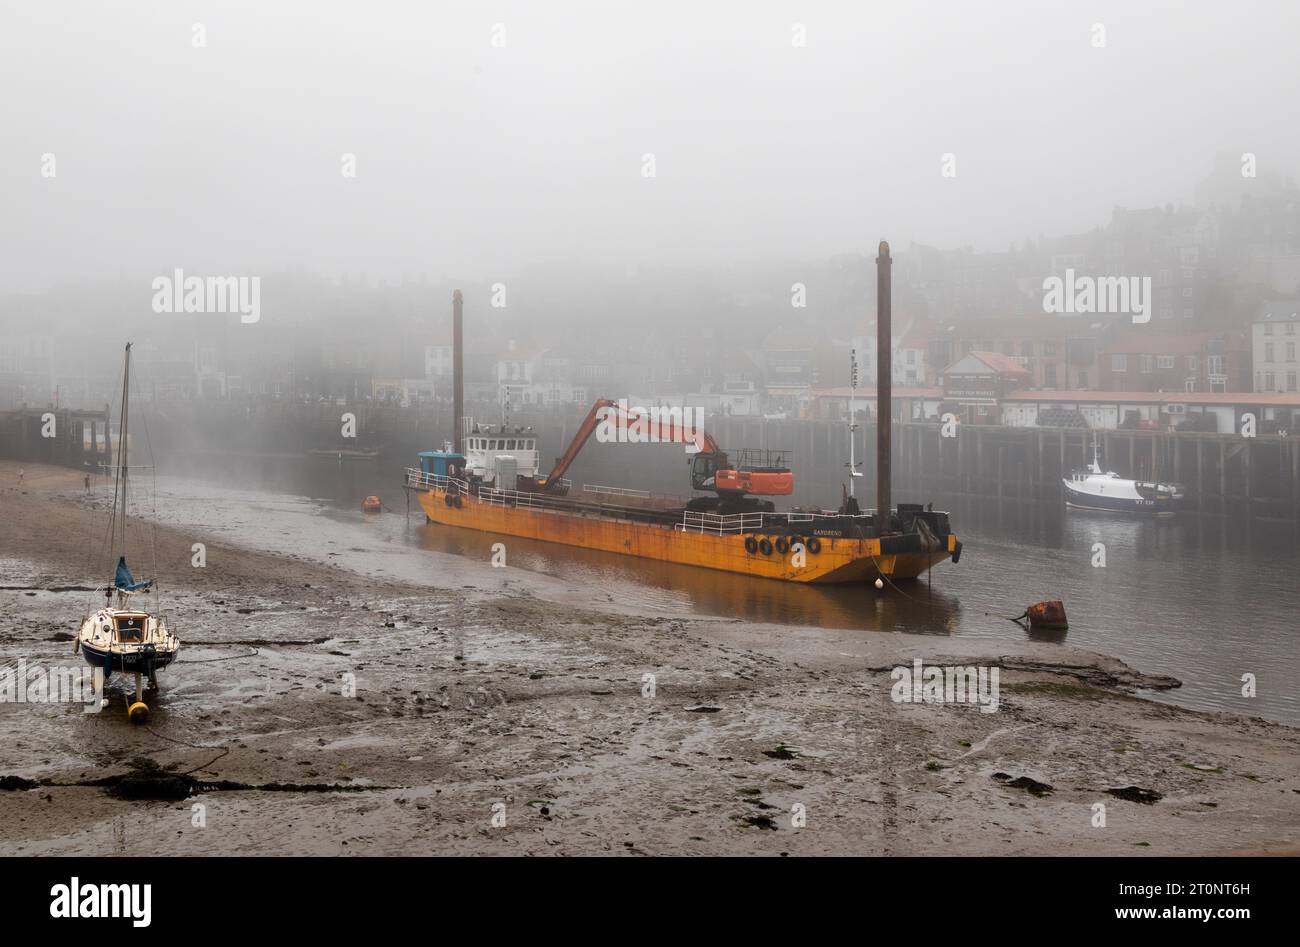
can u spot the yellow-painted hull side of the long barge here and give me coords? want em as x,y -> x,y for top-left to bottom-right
412,489 -> 957,583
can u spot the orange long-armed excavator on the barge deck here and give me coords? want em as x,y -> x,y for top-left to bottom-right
519,398 -> 794,513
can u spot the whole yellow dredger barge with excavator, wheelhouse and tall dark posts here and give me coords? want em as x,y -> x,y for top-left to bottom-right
404,241 -> 962,583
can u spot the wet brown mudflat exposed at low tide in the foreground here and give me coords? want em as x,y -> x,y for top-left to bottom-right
0,463 -> 1300,855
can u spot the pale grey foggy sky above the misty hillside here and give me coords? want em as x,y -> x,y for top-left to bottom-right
0,0 -> 1300,291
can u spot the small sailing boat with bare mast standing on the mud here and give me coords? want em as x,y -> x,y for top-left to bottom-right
73,342 -> 181,723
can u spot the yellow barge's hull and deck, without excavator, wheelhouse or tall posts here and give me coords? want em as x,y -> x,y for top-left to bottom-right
404,465 -> 961,583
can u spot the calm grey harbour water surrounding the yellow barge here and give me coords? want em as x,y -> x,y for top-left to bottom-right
142,457 -> 1300,725
